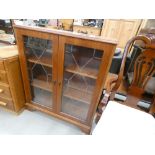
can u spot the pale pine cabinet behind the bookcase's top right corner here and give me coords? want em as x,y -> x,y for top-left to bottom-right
101,19 -> 142,48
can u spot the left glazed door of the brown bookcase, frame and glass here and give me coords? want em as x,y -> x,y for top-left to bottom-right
17,30 -> 58,110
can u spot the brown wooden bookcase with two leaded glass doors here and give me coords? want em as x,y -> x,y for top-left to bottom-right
14,26 -> 116,133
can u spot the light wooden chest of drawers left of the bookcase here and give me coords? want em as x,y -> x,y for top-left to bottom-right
0,46 -> 25,113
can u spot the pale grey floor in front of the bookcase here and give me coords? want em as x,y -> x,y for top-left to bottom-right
0,109 -> 88,135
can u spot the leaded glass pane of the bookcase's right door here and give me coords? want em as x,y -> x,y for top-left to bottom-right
61,44 -> 103,121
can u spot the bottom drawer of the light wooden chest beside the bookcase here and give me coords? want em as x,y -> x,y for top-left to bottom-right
0,97 -> 14,110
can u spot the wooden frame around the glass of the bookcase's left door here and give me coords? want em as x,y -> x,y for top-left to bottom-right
14,27 -> 58,111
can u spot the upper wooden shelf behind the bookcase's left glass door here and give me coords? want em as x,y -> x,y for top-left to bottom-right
27,54 -> 53,67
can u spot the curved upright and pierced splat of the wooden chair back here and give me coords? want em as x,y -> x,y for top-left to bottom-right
110,36 -> 155,109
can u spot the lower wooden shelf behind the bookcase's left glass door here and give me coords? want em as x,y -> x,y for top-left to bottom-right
31,79 -> 53,92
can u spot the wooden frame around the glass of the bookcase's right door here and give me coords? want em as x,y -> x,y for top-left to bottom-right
57,36 -> 116,126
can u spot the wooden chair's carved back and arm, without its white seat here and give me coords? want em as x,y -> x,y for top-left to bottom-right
96,35 -> 155,123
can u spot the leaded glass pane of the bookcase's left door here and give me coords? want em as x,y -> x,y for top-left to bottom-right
24,36 -> 53,108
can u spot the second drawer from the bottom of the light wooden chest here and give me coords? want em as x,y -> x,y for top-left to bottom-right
0,84 -> 11,98
